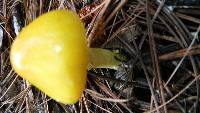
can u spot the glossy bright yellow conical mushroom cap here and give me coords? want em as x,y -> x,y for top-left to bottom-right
10,10 -> 88,104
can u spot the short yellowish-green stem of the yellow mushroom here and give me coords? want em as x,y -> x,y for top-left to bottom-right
88,48 -> 126,70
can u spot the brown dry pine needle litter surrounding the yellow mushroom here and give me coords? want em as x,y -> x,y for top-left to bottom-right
0,0 -> 200,113
